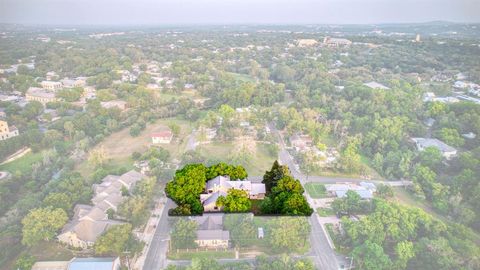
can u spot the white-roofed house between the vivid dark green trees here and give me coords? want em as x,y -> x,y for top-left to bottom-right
200,176 -> 265,212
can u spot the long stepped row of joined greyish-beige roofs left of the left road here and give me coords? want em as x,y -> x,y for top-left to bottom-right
57,170 -> 143,249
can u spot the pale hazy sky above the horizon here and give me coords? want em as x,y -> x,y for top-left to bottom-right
0,0 -> 480,25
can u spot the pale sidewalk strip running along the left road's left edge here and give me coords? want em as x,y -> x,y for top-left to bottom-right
133,197 -> 167,270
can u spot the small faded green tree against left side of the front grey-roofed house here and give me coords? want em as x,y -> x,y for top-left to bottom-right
171,218 -> 198,249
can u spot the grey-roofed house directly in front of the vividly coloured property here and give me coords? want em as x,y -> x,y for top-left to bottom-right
193,213 -> 230,248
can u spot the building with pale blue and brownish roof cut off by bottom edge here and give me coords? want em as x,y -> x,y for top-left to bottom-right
32,257 -> 121,270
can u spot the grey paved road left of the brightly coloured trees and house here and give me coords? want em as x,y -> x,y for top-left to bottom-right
143,199 -> 175,270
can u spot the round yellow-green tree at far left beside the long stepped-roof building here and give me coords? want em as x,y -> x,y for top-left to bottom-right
22,207 -> 68,246
